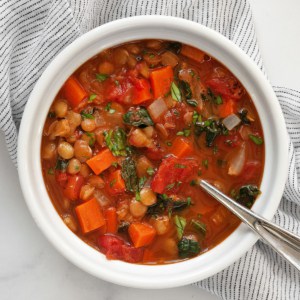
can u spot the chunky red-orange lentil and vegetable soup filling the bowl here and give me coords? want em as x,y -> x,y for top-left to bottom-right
41,40 -> 264,264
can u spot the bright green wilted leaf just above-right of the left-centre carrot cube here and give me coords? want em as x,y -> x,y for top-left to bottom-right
103,127 -> 130,156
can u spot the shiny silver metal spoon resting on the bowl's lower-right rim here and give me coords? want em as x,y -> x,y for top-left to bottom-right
199,180 -> 300,271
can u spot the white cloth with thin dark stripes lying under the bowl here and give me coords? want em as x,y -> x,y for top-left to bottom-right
0,0 -> 300,300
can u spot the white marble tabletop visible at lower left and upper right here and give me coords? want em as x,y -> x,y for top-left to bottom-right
0,0 -> 300,300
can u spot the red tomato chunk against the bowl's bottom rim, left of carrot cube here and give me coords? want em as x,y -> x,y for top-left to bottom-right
98,234 -> 144,263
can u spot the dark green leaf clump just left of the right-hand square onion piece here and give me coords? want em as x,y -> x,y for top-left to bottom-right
195,119 -> 228,147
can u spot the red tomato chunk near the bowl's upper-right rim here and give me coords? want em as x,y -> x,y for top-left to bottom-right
206,76 -> 244,100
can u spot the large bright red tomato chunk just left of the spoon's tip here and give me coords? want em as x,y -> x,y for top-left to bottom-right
151,156 -> 197,194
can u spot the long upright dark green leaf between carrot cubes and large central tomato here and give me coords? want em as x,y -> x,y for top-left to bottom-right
121,157 -> 139,193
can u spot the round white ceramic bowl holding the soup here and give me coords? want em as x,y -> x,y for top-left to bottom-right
18,16 -> 288,288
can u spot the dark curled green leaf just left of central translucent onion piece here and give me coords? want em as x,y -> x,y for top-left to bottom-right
123,107 -> 154,128
